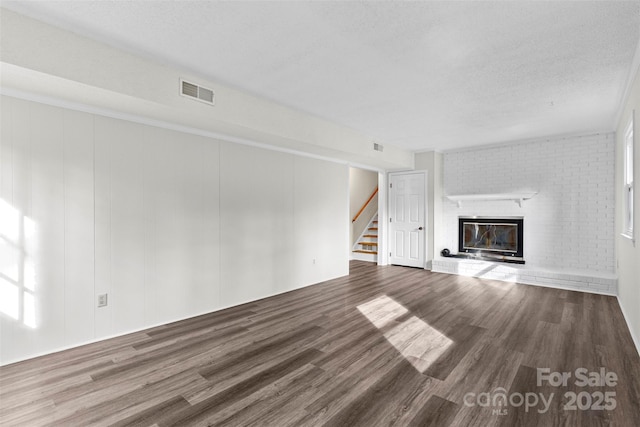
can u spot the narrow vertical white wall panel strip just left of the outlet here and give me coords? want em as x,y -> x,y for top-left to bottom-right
63,110 -> 95,345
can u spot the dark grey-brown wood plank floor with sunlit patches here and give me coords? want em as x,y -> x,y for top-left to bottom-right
0,262 -> 640,427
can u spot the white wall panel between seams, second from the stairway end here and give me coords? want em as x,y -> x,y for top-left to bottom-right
220,143 -> 293,305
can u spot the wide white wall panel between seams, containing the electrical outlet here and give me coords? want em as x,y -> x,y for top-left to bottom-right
95,116 -> 220,336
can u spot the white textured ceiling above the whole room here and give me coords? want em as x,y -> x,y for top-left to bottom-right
2,1 -> 640,151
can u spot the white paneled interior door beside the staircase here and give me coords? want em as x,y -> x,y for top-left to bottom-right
389,172 -> 426,268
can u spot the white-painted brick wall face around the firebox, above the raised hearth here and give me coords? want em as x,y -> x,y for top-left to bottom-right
441,133 -> 615,273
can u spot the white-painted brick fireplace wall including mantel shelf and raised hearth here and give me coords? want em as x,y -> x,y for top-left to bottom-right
431,133 -> 617,295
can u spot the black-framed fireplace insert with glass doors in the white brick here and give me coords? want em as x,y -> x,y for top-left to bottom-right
458,217 -> 524,264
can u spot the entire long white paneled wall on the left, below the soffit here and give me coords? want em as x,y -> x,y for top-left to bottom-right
0,97 -> 349,364
